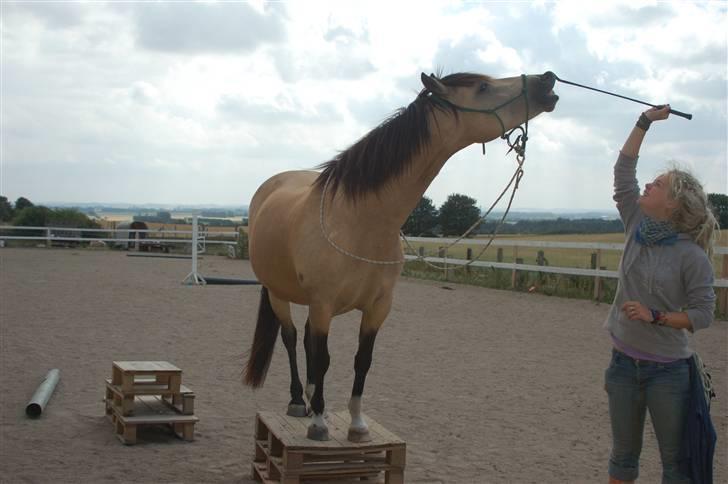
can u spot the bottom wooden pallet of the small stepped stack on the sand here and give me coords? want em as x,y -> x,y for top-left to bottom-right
110,395 -> 199,445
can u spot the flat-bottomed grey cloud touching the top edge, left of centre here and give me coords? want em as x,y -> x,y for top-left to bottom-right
134,2 -> 285,54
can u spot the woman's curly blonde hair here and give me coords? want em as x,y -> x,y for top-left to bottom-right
666,168 -> 719,257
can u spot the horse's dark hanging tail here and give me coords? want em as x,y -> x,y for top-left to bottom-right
243,286 -> 281,388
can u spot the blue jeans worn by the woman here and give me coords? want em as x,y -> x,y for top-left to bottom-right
604,350 -> 691,484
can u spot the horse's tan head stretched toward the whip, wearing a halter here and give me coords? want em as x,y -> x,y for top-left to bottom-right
420,71 -> 559,143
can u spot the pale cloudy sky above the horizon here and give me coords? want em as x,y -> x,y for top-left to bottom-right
0,0 -> 728,211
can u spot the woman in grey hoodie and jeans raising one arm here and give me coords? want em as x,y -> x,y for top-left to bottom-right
605,105 -> 717,483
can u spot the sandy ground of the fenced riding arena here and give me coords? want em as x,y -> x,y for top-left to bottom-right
0,248 -> 728,483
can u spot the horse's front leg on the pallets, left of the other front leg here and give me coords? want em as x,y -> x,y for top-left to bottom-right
307,306 -> 332,440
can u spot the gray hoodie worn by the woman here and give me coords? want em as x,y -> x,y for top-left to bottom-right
604,153 -> 715,358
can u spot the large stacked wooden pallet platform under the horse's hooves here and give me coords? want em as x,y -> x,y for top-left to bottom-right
252,411 -> 406,484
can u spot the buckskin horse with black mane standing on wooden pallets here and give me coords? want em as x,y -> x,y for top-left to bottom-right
243,72 -> 558,443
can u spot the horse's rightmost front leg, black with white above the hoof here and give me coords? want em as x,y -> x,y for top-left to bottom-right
347,295 -> 392,442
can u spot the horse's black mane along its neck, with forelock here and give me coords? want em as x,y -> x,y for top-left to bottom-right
315,72 -> 490,201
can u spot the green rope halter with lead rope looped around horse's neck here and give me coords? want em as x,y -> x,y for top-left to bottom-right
319,74 -> 530,270
